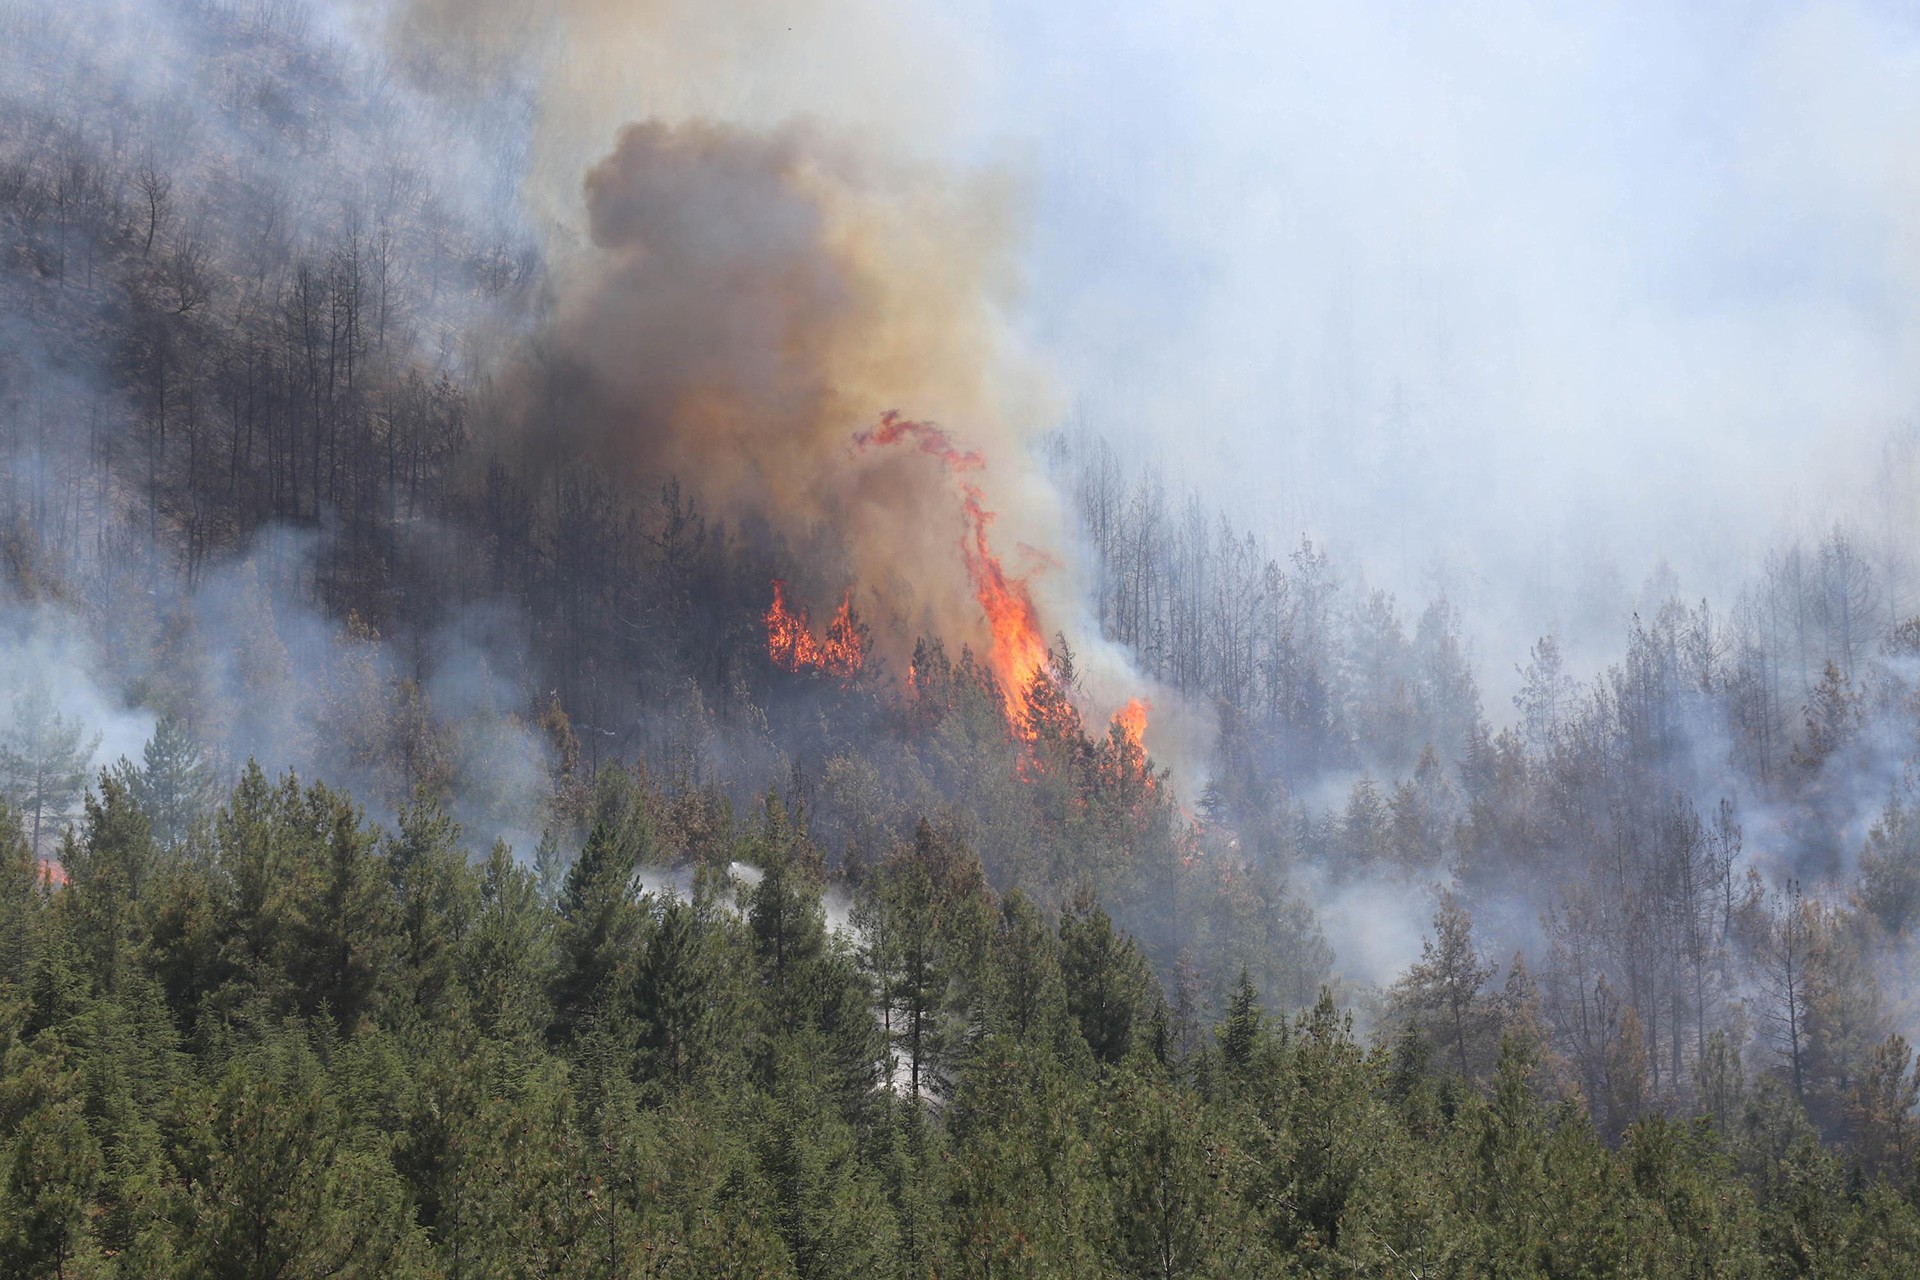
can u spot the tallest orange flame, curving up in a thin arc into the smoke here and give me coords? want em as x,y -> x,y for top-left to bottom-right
852,411 -> 1046,737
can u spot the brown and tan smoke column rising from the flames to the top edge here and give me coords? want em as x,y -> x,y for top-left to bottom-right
382,0 -> 1054,652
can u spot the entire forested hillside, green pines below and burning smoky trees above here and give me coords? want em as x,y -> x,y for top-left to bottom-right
11,0 -> 1920,1276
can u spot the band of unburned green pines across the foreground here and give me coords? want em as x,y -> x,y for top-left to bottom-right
0,770 -> 1920,1280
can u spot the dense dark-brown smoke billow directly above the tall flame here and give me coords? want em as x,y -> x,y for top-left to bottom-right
553,123 -> 1052,652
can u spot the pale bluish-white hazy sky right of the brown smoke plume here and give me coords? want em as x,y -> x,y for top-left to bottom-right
948,0 -> 1920,652
